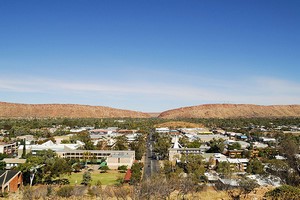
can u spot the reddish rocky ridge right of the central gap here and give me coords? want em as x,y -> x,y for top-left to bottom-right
158,104 -> 300,119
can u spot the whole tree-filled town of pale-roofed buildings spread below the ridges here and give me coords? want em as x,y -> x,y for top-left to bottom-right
0,118 -> 300,199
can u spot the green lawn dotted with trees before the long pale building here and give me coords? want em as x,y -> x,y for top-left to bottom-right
61,171 -> 125,185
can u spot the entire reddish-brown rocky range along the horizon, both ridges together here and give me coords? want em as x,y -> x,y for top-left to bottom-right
0,102 -> 300,119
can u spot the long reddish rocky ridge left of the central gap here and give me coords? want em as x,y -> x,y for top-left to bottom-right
0,102 -> 150,118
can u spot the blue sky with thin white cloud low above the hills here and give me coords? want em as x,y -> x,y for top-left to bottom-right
0,0 -> 300,112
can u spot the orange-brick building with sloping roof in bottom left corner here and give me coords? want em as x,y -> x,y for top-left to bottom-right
0,170 -> 23,193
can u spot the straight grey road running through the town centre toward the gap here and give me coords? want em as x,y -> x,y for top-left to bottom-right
144,133 -> 160,179
